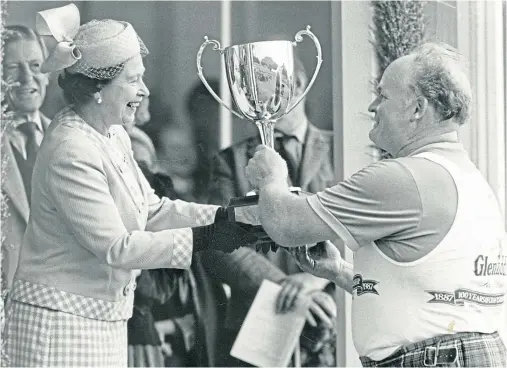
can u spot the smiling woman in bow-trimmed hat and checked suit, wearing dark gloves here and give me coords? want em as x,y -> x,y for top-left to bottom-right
4,4 -> 270,367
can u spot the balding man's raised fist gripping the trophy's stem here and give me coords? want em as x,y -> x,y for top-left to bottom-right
245,144 -> 288,188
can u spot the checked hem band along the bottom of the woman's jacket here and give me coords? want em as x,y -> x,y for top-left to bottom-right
9,279 -> 136,321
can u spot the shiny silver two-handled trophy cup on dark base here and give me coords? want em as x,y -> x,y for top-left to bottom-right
197,26 -> 322,252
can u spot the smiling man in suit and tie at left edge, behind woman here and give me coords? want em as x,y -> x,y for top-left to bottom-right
2,26 -> 50,289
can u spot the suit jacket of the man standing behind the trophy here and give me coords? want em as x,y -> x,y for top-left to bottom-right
202,124 -> 336,330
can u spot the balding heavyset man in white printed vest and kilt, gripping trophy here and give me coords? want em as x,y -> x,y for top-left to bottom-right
246,44 -> 507,367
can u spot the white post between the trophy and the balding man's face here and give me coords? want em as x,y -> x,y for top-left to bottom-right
331,1 -> 375,367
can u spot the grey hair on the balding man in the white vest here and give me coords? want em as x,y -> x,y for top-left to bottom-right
411,43 -> 472,125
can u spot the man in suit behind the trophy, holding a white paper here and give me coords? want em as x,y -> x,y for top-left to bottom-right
201,58 -> 336,366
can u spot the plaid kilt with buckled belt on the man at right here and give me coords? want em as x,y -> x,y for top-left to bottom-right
360,332 -> 507,367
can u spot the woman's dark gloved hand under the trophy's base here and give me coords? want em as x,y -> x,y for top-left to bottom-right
192,207 -> 273,253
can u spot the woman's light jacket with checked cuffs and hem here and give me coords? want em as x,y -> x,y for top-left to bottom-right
11,108 -> 216,320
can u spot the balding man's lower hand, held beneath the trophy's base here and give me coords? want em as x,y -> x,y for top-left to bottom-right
287,241 -> 343,281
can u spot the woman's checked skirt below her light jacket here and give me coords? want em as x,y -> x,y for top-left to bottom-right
4,301 -> 127,367
